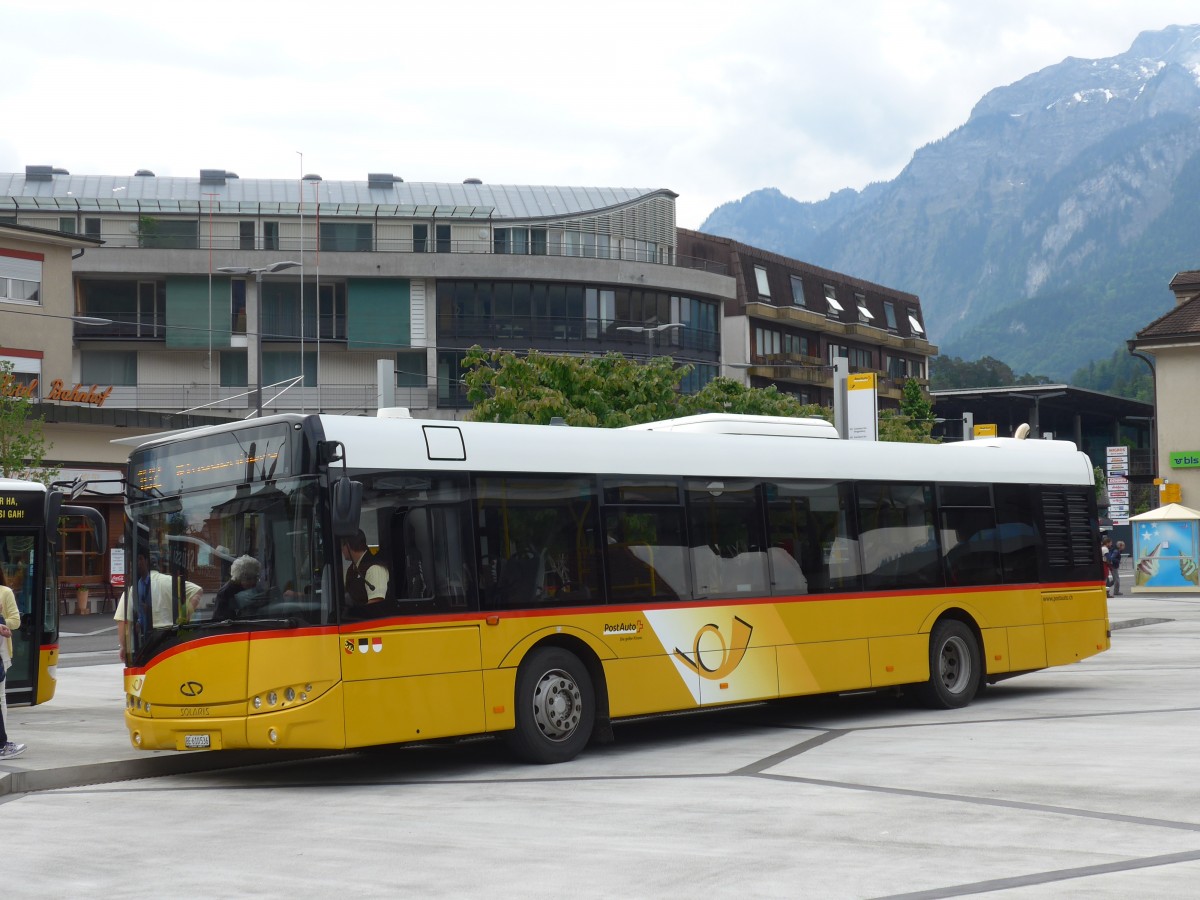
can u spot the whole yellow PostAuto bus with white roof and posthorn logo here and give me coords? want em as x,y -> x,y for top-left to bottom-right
117,414 -> 1109,762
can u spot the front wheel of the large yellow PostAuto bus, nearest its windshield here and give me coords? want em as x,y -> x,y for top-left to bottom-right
508,647 -> 596,763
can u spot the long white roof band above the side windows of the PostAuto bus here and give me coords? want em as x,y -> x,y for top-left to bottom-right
320,415 -> 1093,485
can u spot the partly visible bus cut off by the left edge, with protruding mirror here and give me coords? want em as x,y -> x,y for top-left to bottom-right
0,479 -> 106,706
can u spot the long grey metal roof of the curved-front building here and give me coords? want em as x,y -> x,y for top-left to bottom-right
0,167 -> 677,221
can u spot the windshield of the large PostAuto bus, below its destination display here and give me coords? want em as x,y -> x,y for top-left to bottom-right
124,476 -> 334,658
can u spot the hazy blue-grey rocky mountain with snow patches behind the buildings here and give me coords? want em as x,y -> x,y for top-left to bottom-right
701,25 -> 1200,379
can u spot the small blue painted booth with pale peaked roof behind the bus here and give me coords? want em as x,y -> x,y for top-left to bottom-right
1129,503 -> 1200,593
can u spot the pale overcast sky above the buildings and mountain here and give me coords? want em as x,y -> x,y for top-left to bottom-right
0,0 -> 1200,228
